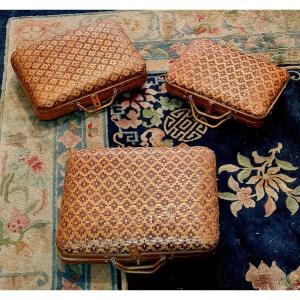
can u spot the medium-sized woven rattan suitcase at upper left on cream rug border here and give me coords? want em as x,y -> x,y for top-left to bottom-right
11,20 -> 147,120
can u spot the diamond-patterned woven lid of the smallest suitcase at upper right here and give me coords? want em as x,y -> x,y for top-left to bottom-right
167,40 -> 289,117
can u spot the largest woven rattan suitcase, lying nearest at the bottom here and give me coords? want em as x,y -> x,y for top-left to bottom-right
56,147 -> 219,273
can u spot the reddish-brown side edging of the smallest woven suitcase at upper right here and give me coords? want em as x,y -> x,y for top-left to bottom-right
166,79 -> 289,128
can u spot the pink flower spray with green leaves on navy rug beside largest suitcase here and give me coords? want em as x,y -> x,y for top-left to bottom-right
219,143 -> 300,217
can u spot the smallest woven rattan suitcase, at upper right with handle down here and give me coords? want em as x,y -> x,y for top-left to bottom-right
166,39 -> 289,128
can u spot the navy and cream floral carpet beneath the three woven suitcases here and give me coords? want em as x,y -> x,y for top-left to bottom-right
0,11 -> 300,289
